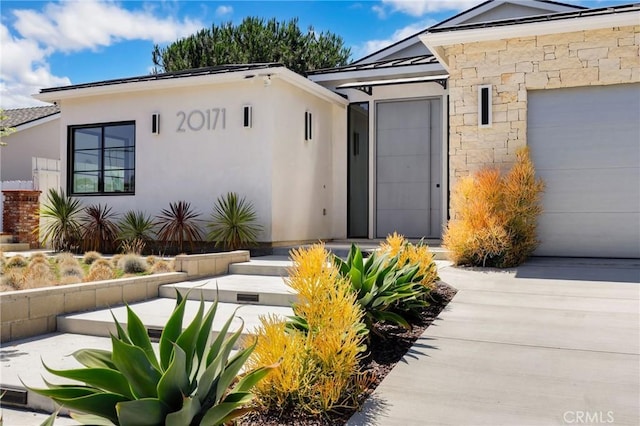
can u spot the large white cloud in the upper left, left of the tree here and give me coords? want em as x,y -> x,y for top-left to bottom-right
0,0 -> 203,108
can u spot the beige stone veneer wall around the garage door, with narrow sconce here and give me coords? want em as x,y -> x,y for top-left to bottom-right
444,26 -> 640,188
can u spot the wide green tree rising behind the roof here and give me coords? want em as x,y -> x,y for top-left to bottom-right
152,17 -> 351,75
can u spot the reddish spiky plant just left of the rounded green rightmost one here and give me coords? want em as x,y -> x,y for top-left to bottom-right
157,201 -> 202,252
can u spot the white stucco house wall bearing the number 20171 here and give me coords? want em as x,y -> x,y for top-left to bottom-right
53,73 -> 346,242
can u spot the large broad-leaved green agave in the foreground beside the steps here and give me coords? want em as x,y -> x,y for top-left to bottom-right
30,294 -> 276,426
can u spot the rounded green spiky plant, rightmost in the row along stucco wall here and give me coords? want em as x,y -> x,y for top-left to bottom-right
207,192 -> 262,250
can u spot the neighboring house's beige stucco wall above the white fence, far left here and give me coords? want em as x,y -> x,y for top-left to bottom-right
0,119 -> 60,181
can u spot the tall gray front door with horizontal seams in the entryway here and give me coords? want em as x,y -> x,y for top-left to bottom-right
376,99 -> 442,238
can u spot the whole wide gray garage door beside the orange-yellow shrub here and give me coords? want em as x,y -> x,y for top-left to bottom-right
527,84 -> 640,258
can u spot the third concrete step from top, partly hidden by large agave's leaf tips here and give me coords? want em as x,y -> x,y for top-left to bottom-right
57,298 -> 293,346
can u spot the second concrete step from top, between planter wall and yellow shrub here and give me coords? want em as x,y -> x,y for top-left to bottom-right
160,274 -> 297,306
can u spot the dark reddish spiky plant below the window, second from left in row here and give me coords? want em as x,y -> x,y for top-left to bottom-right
82,204 -> 118,253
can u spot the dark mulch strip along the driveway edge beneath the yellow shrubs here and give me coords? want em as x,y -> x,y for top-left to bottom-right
238,281 -> 457,426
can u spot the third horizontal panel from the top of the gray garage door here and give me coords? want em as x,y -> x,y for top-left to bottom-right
538,168 -> 640,213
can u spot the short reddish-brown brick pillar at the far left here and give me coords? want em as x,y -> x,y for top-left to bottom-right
2,189 -> 40,248
